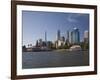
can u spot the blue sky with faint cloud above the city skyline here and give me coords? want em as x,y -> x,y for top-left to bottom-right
22,11 -> 89,46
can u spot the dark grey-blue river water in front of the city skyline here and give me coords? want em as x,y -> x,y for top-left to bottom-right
22,51 -> 89,69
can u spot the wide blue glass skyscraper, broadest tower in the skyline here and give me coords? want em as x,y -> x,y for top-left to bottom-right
71,28 -> 80,44
